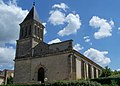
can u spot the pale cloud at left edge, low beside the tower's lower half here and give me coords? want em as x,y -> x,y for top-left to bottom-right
0,47 -> 15,68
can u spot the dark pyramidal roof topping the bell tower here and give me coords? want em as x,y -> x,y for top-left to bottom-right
23,5 -> 41,22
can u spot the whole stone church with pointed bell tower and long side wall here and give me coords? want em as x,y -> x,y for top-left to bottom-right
14,6 -> 102,84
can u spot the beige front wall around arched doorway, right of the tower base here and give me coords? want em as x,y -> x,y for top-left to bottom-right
31,54 -> 69,82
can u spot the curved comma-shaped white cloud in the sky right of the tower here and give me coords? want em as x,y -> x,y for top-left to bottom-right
58,13 -> 81,36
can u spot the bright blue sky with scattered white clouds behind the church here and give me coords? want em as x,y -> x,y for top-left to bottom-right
0,0 -> 120,70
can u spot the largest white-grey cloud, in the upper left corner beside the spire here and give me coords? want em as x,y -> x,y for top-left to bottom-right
0,1 -> 28,42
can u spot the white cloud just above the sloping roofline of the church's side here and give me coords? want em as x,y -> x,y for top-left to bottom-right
84,48 -> 111,66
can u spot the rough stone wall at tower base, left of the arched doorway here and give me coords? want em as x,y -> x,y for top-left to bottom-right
14,59 -> 31,83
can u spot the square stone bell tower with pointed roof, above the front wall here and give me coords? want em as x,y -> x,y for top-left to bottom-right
16,5 -> 44,59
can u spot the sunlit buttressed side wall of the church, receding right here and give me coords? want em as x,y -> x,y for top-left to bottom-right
75,55 -> 102,79
